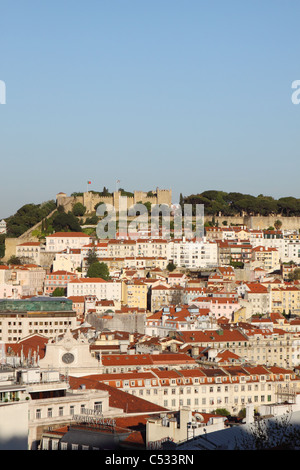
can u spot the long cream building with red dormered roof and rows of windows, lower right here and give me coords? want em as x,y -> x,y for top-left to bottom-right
97,365 -> 300,414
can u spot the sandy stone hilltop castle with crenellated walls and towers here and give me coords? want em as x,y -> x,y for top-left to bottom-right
56,188 -> 172,213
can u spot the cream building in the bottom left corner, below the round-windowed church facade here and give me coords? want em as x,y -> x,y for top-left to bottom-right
0,367 -> 121,450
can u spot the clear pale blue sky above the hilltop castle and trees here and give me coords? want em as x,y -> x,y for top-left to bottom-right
0,0 -> 300,218
